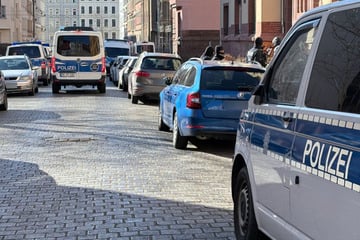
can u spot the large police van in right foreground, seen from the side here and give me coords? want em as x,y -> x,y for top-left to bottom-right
232,0 -> 360,240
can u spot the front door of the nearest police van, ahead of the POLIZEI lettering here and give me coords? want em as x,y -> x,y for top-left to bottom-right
250,19 -> 316,233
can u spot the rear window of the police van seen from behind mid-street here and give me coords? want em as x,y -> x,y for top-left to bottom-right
56,35 -> 100,57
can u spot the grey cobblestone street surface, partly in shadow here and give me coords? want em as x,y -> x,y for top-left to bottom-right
0,82 -> 235,240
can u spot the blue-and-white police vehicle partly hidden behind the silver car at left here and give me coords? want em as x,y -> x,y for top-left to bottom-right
6,42 -> 51,86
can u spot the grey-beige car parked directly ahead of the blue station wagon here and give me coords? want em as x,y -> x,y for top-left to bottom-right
128,52 -> 182,104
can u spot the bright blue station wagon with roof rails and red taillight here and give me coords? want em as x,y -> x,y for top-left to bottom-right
158,58 -> 265,149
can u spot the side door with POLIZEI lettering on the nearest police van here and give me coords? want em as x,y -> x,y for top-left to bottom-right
290,4 -> 360,240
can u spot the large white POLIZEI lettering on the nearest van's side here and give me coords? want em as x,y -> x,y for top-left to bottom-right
303,140 -> 353,179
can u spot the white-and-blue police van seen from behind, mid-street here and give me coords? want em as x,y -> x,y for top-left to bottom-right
51,28 -> 106,93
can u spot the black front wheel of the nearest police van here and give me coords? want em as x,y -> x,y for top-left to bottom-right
234,167 -> 259,240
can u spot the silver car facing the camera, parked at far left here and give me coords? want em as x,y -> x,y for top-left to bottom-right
0,55 -> 39,96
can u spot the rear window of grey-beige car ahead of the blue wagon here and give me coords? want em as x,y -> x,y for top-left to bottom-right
141,57 -> 181,71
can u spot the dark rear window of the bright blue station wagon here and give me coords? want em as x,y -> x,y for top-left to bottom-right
200,68 -> 264,91
